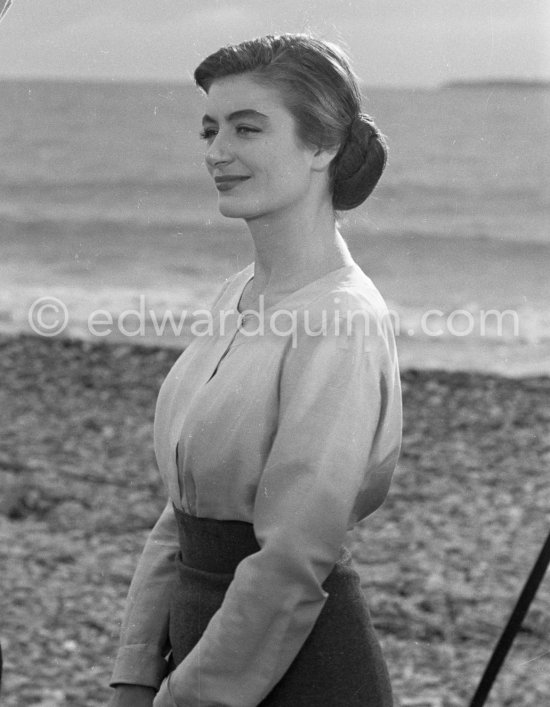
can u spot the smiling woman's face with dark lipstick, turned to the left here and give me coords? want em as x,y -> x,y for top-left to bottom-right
202,75 -> 322,220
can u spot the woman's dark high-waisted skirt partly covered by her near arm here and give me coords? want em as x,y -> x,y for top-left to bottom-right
169,508 -> 393,707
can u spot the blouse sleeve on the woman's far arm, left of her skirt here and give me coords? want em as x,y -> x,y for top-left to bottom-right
111,502 -> 179,689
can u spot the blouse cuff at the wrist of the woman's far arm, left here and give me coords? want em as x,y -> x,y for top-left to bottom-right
109,643 -> 168,690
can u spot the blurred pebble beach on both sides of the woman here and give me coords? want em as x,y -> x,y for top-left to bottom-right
0,336 -> 550,707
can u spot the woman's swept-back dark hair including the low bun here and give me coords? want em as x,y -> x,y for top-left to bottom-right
194,34 -> 387,211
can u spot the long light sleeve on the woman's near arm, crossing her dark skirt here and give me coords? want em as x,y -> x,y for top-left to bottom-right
154,318 -> 401,707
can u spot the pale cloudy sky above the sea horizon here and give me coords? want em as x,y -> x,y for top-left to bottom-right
0,0 -> 550,87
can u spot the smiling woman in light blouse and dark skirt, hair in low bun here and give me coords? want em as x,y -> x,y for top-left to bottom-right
111,35 -> 401,707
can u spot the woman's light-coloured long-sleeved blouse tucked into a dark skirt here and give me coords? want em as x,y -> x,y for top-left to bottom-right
111,264 -> 401,707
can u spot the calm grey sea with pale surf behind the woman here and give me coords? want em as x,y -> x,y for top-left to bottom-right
0,80 -> 550,376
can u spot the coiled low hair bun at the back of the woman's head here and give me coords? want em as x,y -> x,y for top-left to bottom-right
333,113 -> 387,211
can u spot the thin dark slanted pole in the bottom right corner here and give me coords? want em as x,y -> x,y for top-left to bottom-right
470,534 -> 550,707
